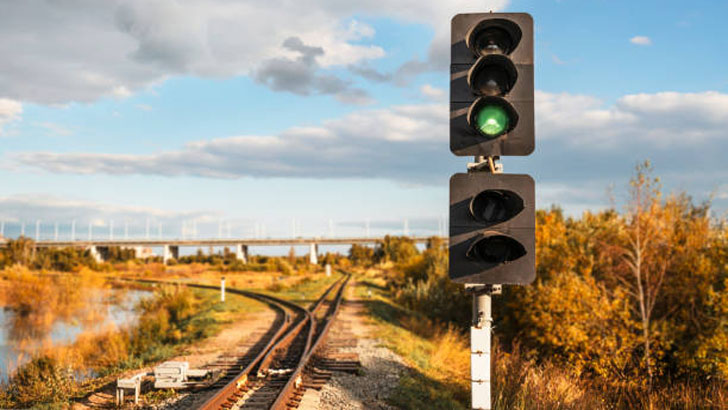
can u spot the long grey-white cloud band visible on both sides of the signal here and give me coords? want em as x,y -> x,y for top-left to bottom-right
12,91 -> 728,183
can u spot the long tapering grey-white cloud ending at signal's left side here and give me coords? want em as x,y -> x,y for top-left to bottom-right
14,104 -> 450,181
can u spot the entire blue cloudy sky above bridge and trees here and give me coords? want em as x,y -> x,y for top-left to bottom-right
0,0 -> 728,242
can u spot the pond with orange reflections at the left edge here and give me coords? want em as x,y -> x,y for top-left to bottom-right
0,289 -> 152,382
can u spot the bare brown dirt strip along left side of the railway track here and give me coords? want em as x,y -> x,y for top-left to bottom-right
72,310 -> 276,410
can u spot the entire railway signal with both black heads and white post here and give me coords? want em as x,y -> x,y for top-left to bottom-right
449,13 -> 536,409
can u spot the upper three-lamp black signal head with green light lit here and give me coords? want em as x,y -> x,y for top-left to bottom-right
450,13 -> 534,157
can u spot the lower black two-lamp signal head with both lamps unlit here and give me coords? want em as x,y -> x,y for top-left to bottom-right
450,172 -> 536,284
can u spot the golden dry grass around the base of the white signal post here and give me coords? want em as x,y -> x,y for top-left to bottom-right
357,272 -> 728,410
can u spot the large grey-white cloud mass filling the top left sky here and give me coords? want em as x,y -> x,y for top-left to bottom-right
0,0 -> 508,104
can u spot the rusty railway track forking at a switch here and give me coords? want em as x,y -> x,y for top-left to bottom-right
196,276 -> 349,410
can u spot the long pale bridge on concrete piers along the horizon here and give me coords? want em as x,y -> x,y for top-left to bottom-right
0,236 -> 448,264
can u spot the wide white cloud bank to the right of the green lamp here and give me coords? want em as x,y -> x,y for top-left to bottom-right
536,91 -> 728,149
